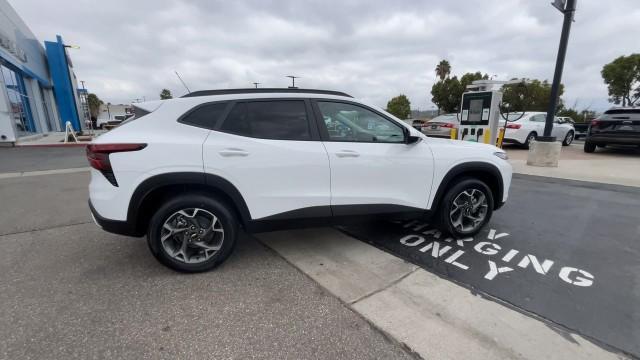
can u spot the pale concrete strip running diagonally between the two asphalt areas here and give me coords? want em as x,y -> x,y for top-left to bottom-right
257,228 -> 619,359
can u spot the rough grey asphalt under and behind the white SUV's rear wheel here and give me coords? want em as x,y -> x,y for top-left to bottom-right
0,173 -> 412,359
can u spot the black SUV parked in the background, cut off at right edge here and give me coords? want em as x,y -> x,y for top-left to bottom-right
584,108 -> 640,153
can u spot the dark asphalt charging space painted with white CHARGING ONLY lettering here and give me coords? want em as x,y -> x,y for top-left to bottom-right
343,175 -> 640,357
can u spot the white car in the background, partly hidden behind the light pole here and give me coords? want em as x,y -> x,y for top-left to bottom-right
502,112 -> 576,148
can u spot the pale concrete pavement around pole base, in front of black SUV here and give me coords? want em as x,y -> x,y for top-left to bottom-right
504,143 -> 640,186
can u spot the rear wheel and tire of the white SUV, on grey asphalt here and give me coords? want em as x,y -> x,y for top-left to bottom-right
147,194 -> 238,273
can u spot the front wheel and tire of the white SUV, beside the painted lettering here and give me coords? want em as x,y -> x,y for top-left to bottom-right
436,177 -> 494,238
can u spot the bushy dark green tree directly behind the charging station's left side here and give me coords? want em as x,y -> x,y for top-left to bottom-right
431,72 -> 489,113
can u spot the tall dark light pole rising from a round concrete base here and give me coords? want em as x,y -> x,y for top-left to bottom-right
536,0 -> 576,142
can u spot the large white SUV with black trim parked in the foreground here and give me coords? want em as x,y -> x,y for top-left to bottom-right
87,89 -> 511,272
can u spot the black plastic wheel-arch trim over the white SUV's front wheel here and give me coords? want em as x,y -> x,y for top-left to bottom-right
431,161 -> 504,210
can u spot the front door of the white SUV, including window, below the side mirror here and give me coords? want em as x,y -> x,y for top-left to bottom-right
314,100 -> 433,215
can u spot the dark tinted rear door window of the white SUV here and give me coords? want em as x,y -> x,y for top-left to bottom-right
220,100 -> 311,140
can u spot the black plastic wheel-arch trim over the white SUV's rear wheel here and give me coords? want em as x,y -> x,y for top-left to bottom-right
127,172 -> 251,232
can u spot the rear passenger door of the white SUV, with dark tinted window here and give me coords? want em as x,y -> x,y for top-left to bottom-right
203,98 -> 331,219
